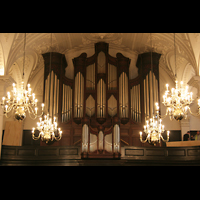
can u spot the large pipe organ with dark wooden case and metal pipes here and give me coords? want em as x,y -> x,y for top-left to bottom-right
43,42 -> 161,153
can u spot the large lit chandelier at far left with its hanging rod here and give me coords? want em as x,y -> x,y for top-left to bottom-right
1,33 -> 44,120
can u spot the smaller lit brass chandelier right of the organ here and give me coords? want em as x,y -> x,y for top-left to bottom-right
140,103 -> 170,146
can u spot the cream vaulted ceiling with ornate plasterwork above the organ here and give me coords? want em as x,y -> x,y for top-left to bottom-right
0,33 -> 200,94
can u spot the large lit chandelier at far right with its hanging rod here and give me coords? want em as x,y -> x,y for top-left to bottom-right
162,33 -> 200,121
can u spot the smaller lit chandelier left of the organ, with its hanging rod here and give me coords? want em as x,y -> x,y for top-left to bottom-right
32,34 -> 62,143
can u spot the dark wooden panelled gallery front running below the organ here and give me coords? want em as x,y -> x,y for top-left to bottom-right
0,145 -> 200,166
